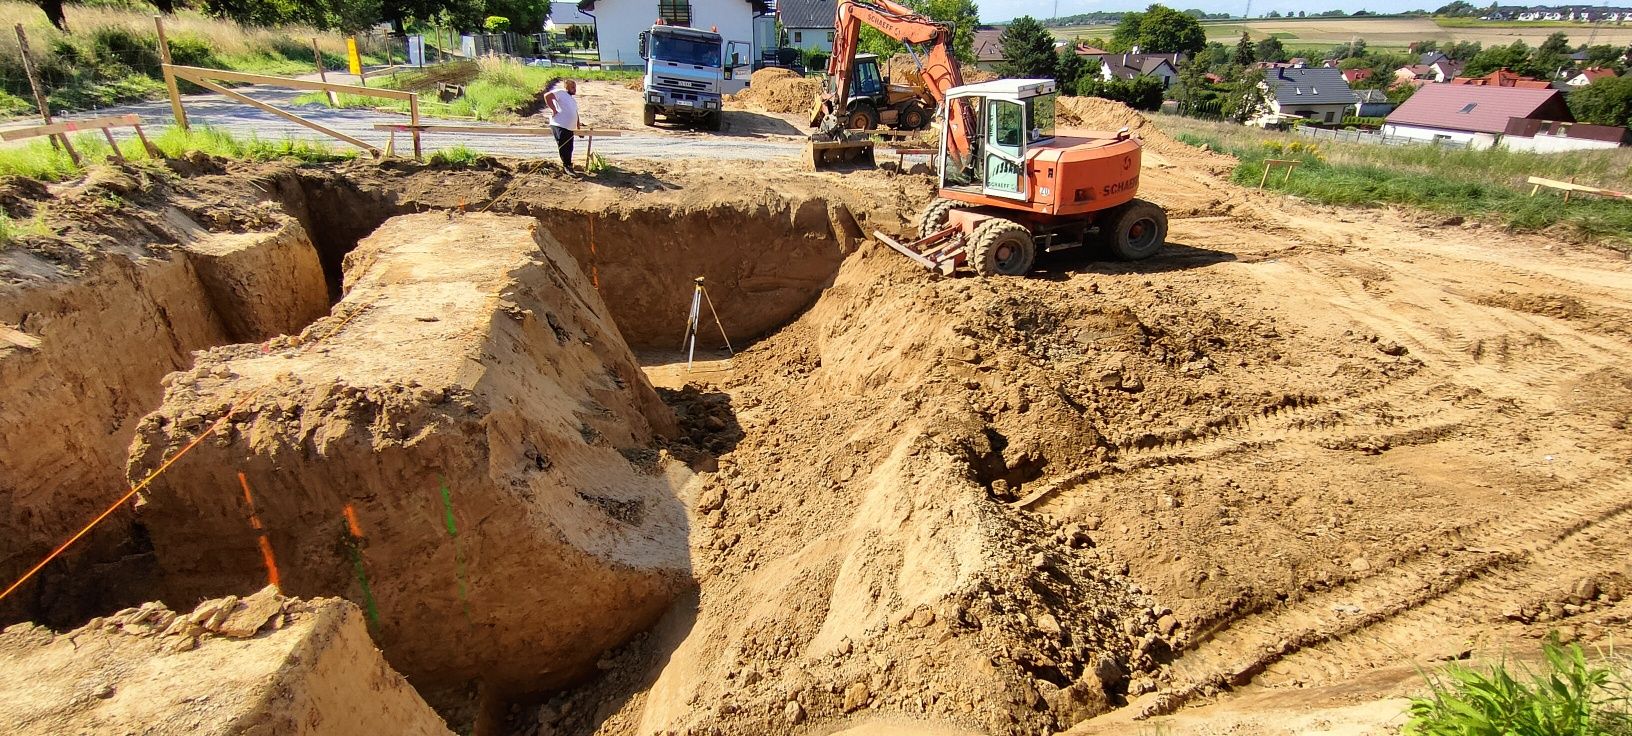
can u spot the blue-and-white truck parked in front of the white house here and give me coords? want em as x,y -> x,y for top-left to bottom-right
640,24 -> 751,131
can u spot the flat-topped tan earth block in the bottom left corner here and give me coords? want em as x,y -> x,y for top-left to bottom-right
0,587 -> 452,736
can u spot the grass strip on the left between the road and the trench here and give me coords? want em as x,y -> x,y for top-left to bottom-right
0,126 -> 356,181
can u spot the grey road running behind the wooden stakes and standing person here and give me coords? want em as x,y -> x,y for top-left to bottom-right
5,85 -> 801,160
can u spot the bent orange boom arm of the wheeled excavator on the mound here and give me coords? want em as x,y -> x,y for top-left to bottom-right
813,0 -> 974,162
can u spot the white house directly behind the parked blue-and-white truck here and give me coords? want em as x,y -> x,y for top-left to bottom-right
578,0 -> 770,67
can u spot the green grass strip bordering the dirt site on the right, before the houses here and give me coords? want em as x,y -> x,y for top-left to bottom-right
1155,116 -> 1632,250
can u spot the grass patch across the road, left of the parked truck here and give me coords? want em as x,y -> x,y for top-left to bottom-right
295,59 -> 641,121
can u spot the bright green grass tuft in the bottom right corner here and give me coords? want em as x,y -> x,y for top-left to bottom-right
1400,641 -> 1632,736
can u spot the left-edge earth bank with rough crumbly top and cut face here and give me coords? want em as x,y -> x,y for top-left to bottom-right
0,168 -> 328,625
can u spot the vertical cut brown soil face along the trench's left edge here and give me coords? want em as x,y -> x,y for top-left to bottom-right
0,215 -> 326,623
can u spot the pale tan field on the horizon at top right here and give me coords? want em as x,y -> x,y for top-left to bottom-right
1054,18 -> 1632,49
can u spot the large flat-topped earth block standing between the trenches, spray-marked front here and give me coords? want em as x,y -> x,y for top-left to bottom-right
129,212 -> 689,701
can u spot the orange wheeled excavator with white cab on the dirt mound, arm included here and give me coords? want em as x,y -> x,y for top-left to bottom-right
809,0 -> 1167,276
